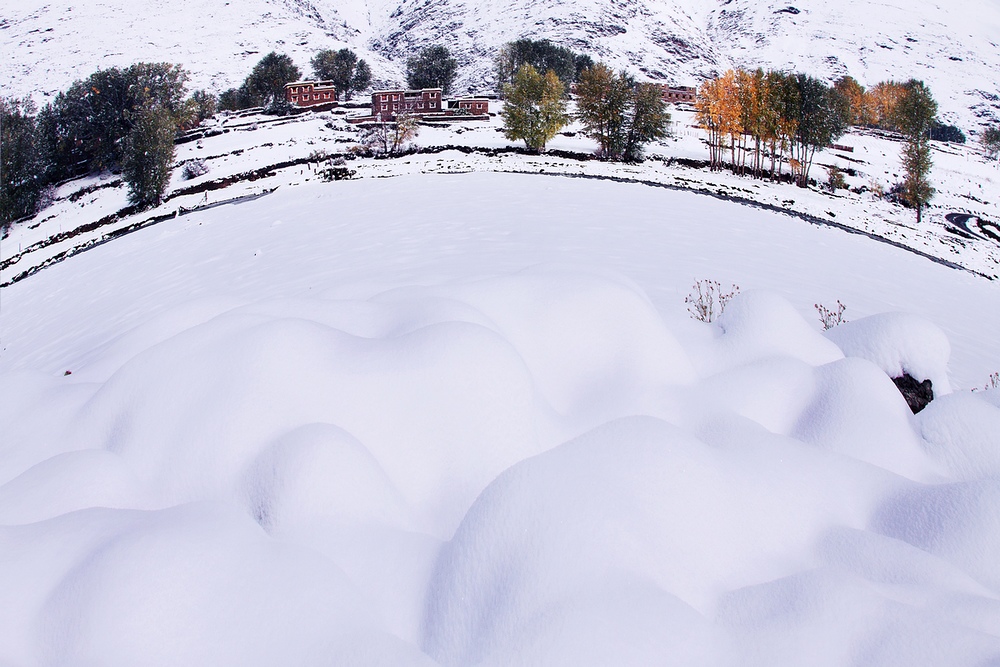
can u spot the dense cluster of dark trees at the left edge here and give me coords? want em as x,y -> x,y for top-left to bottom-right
0,63 -> 205,223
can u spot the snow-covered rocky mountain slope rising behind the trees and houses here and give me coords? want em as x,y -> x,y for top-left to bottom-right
0,0 -> 1000,130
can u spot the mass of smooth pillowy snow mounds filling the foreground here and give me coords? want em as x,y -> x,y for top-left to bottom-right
0,258 -> 1000,667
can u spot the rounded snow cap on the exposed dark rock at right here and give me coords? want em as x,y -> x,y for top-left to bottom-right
826,313 -> 951,396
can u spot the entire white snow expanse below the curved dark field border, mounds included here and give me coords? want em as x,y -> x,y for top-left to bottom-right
0,174 -> 1000,667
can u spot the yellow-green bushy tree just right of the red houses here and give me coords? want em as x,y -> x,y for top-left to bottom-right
500,64 -> 569,151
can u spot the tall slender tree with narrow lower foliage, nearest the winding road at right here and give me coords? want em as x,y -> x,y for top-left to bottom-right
893,79 -> 937,224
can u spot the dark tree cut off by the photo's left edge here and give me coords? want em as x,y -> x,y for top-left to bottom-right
0,98 -> 45,229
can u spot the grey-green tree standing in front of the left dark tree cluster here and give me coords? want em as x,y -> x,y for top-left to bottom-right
122,104 -> 177,206
